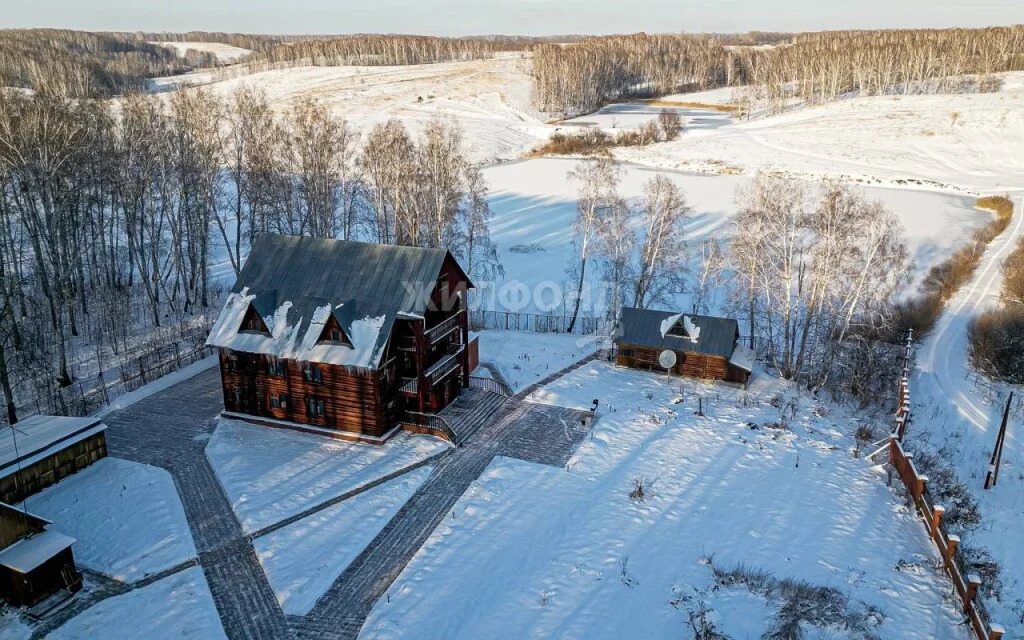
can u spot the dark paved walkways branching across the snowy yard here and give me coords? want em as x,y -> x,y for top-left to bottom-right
44,353 -> 597,640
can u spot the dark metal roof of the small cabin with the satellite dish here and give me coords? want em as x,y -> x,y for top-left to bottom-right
615,307 -> 739,359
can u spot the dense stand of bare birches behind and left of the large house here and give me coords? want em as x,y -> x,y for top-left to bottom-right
0,88 -> 501,423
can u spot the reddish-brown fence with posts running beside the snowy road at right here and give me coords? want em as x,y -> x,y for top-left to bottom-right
889,333 -> 1006,640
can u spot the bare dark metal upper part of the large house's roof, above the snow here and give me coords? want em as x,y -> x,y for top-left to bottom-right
231,233 -> 472,364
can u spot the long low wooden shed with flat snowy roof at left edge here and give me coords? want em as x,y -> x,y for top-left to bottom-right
0,416 -> 106,504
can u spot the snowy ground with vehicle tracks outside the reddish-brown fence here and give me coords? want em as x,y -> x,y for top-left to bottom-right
909,192 -> 1024,638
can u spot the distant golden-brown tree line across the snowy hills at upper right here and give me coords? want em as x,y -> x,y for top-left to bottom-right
532,26 -> 1024,115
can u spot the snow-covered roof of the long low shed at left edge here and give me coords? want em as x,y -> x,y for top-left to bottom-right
0,416 -> 106,478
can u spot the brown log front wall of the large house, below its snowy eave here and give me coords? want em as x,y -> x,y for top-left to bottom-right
220,349 -> 385,437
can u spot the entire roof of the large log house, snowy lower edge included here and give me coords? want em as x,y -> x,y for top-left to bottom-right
207,233 -> 473,369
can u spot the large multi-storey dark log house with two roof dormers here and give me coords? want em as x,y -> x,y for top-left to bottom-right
207,234 -> 475,443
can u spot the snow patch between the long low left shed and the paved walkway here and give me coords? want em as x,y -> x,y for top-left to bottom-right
28,458 -> 196,582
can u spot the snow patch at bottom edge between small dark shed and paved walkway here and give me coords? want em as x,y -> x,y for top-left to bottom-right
47,567 -> 227,640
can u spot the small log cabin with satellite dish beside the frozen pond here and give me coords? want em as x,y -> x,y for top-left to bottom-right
614,307 -> 755,386
